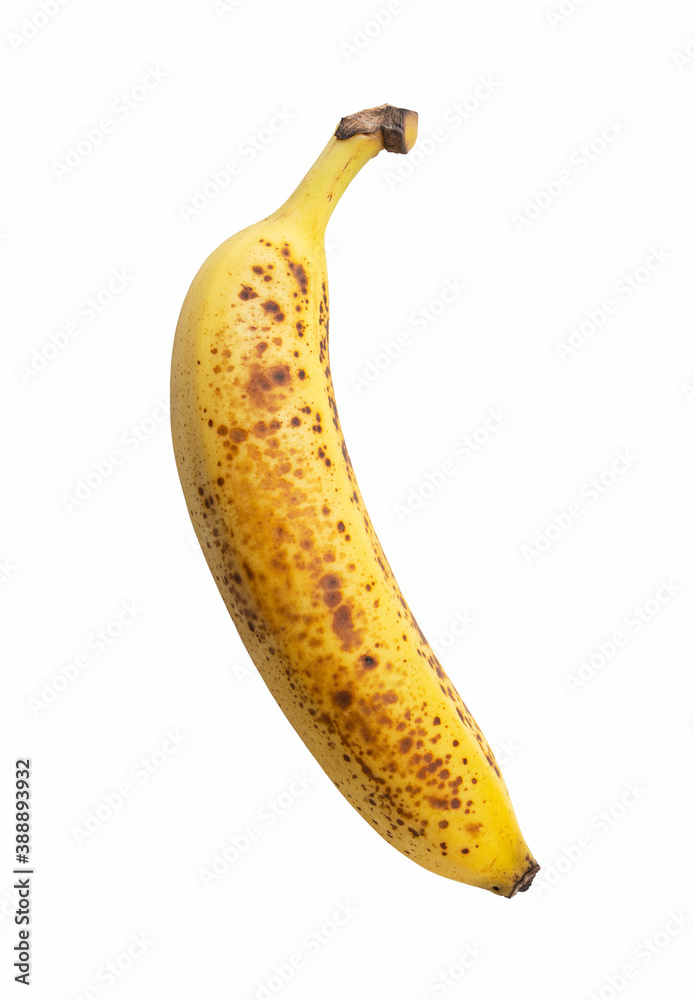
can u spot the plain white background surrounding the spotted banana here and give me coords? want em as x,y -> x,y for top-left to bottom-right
0,0 -> 694,1000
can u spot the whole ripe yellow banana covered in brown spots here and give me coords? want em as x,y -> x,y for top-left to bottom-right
171,105 -> 539,897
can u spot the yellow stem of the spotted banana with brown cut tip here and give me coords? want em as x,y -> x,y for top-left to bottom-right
270,104 -> 417,237
